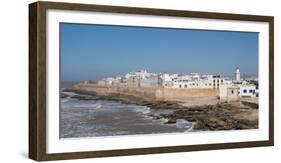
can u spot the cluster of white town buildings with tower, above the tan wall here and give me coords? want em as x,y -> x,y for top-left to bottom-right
94,68 -> 259,98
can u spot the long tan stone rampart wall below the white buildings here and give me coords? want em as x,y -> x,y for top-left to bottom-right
73,84 -> 219,101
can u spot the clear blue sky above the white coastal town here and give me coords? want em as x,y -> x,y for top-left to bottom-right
60,23 -> 258,81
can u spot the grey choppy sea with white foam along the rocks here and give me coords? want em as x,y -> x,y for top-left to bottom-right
60,91 -> 192,138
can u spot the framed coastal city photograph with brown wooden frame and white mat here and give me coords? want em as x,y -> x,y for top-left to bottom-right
29,2 -> 274,160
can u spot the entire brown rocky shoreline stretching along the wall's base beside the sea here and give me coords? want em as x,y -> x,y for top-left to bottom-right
62,89 -> 258,131
